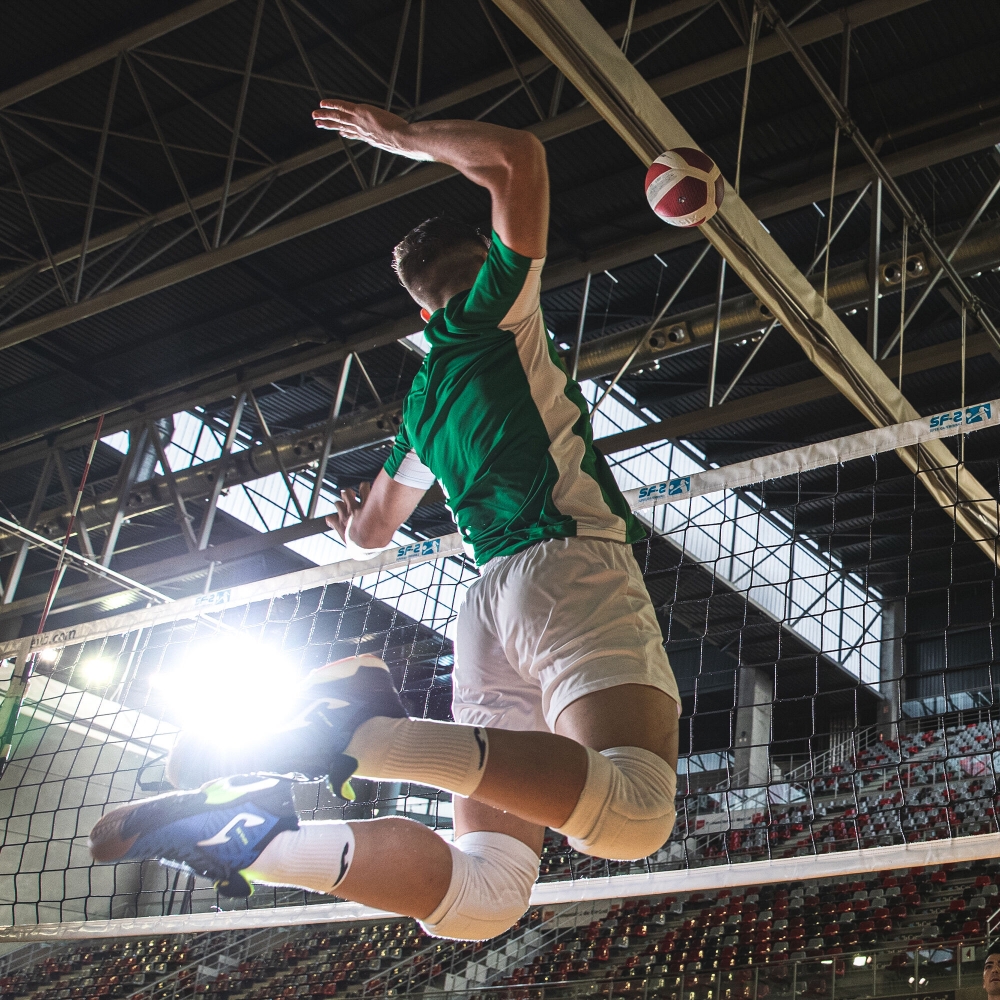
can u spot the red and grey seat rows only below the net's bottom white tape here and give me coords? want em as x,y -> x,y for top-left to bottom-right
0,848 -> 1000,1000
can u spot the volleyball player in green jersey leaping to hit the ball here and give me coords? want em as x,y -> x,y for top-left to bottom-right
91,100 -> 678,939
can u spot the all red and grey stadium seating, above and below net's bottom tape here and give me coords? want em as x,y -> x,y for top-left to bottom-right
0,720 -> 1000,1000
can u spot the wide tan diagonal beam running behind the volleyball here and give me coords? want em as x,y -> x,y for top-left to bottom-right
495,0 -> 1000,564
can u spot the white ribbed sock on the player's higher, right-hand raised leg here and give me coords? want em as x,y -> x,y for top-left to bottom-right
344,716 -> 489,796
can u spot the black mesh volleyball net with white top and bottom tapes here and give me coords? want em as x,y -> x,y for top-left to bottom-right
0,387 -> 1000,937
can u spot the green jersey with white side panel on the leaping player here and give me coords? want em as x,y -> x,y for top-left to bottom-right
385,233 -> 645,566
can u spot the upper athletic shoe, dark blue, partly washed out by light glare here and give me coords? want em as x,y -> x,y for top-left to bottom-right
167,655 -> 406,800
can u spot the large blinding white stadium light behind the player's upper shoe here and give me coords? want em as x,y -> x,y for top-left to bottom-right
151,635 -> 298,743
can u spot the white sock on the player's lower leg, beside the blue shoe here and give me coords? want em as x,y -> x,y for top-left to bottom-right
246,820 -> 354,894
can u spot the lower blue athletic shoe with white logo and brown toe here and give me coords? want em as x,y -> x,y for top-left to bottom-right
87,774 -> 299,896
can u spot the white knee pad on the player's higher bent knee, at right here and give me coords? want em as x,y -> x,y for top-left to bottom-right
559,747 -> 677,861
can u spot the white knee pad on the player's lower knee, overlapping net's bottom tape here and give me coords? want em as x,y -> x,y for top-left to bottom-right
420,831 -> 539,941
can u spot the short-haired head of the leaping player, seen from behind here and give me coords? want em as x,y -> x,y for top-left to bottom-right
392,215 -> 490,312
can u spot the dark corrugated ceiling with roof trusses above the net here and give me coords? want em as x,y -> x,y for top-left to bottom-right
0,0 -> 1000,688
